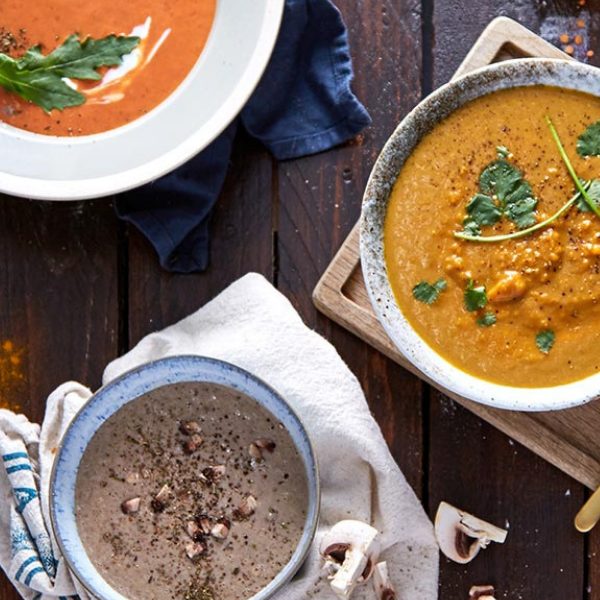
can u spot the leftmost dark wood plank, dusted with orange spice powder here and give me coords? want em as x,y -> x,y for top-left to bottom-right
0,196 -> 119,600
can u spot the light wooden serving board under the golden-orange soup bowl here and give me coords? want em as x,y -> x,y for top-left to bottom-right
313,17 -> 600,488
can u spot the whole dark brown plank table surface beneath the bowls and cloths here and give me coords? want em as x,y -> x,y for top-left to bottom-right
0,0 -> 600,600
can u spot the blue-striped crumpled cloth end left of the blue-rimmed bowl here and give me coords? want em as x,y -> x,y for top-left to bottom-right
0,383 -> 91,600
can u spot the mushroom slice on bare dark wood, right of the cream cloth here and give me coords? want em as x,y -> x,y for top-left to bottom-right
435,502 -> 508,564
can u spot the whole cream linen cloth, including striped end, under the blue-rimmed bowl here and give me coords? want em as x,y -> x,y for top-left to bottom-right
0,274 -> 438,600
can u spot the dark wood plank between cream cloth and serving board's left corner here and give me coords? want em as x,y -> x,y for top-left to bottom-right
277,0 -> 423,494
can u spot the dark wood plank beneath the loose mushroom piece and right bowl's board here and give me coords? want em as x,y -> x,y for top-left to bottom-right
429,0 -> 600,600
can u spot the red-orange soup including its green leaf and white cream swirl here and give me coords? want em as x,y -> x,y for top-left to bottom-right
0,0 -> 216,136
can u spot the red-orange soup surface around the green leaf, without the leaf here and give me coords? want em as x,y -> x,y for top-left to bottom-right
0,0 -> 216,136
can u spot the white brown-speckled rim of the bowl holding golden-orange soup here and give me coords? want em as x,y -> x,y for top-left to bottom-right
360,59 -> 600,411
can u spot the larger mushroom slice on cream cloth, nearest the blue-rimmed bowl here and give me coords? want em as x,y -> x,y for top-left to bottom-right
320,519 -> 380,600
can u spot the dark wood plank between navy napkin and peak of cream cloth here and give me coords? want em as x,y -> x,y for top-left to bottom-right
128,133 -> 273,345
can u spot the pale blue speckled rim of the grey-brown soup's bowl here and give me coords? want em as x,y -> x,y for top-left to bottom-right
50,356 -> 320,600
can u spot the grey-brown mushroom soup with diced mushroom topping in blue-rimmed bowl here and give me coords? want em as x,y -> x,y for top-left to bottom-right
76,383 -> 308,600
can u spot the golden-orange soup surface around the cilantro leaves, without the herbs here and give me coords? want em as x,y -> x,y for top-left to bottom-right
384,86 -> 600,387
